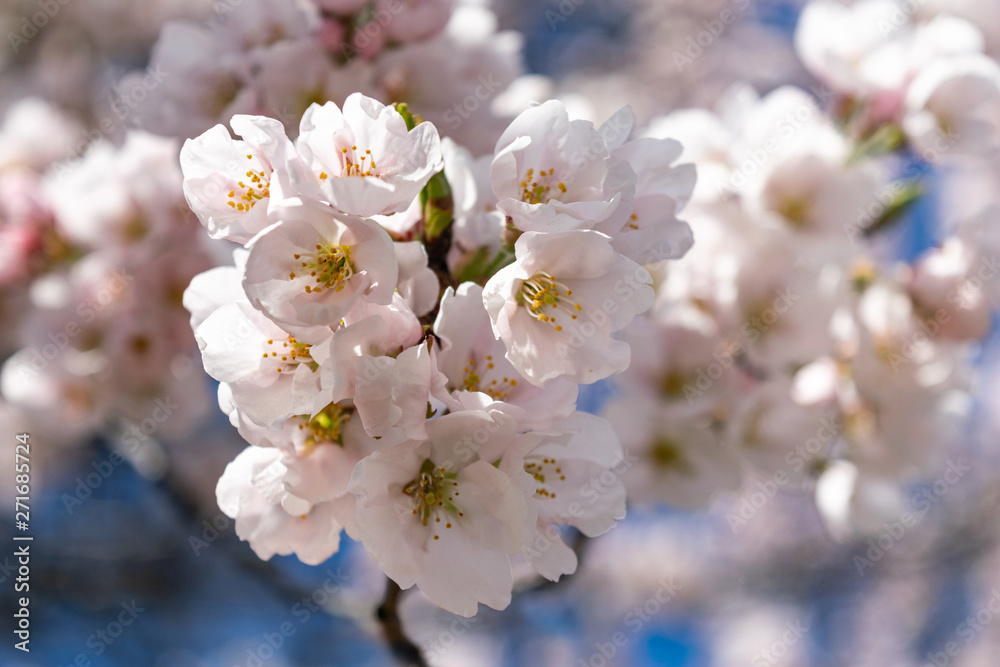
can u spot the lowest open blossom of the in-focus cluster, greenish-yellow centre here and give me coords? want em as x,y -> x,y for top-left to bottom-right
348,410 -> 536,616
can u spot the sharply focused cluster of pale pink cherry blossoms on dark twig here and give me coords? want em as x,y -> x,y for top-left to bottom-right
181,93 -> 694,615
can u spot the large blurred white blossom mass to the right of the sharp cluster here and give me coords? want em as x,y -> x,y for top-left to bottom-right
604,2 -> 1000,530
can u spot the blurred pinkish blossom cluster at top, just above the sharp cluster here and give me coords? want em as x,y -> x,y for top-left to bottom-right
123,0 -> 521,152
